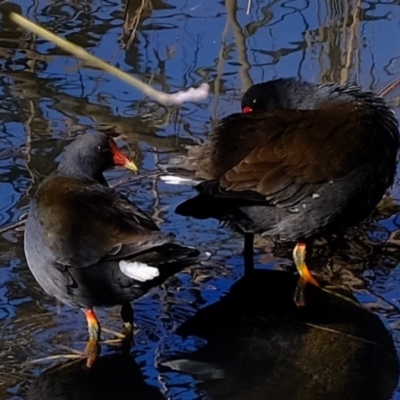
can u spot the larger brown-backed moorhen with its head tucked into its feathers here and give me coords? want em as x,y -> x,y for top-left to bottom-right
176,78 -> 399,304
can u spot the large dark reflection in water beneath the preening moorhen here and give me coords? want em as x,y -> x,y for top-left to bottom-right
164,270 -> 399,400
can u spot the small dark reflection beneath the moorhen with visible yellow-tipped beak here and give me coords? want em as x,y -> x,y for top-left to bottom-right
26,355 -> 165,400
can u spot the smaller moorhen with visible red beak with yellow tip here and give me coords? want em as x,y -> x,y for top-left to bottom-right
25,133 -> 199,367
